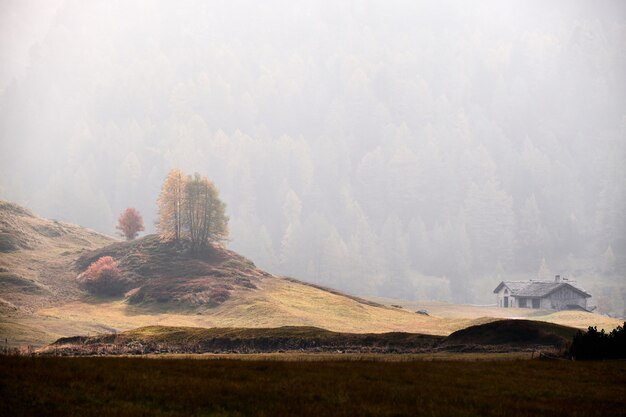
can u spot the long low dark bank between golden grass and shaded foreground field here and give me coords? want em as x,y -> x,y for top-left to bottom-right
39,326 -> 442,355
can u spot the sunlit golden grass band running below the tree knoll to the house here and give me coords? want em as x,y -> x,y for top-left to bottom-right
8,272 -> 622,346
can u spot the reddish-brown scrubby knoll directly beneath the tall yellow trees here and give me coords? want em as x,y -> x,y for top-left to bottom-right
76,235 -> 271,309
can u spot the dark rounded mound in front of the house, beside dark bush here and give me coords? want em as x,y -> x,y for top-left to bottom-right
441,320 -> 577,350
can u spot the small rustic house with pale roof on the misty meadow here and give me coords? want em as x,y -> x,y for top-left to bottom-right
493,275 -> 591,310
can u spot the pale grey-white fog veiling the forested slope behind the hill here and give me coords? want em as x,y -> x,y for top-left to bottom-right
0,0 -> 626,308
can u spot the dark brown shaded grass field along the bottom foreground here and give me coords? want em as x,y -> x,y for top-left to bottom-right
0,357 -> 626,417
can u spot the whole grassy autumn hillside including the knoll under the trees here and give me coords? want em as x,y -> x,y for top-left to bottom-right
0,202 -> 621,347
